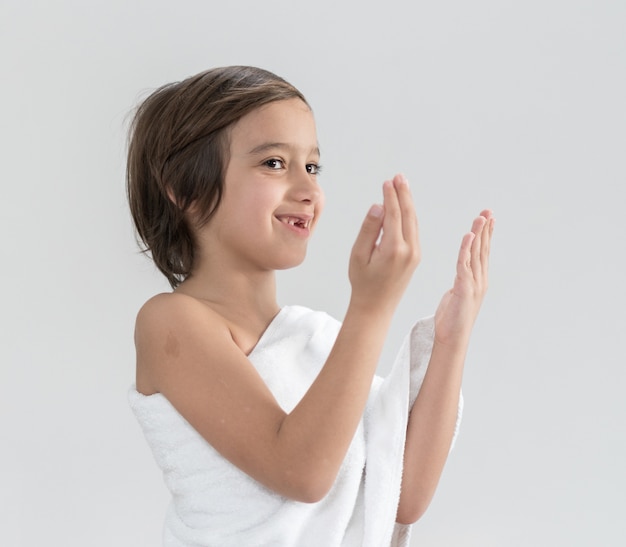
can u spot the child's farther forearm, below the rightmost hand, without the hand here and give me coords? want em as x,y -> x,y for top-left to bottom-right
396,342 -> 466,524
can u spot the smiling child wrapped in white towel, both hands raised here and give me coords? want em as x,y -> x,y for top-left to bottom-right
127,67 -> 494,547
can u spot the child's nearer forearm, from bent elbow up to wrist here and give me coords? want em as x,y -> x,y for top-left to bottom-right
279,305 -> 392,501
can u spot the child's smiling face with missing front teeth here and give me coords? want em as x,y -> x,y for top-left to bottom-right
199,99 -> 324,270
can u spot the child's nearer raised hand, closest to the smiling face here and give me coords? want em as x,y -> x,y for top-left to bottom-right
349,175 -> 421,312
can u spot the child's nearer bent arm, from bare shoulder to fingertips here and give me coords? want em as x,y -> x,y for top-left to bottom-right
136,176 -> 420,502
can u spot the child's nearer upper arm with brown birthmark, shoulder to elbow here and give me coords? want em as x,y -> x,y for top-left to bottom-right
135,293 -> 292,498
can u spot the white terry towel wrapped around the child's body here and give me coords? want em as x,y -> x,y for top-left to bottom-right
129,306 -> 462,547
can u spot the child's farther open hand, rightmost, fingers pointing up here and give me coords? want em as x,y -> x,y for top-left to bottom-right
435,210 -> 495,348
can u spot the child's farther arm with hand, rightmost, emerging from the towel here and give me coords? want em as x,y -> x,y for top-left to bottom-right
396,211 -> 494,524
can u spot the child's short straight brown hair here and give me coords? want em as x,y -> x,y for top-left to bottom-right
126,66 -> 308,288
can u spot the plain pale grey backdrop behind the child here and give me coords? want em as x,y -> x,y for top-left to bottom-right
0,0 -> 626,547
